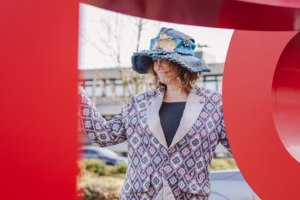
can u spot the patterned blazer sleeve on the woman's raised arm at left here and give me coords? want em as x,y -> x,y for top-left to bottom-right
78,85 -> 134,147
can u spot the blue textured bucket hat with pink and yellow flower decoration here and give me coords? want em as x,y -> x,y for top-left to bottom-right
131,27 -> 211,74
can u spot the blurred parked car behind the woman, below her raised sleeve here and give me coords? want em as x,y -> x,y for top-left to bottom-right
79,146 -> 128,165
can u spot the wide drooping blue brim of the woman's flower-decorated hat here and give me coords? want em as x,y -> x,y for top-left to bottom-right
131,50 -> 211,74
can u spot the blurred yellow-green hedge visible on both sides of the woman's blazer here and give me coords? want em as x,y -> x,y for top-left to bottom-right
77,158 -> 238,200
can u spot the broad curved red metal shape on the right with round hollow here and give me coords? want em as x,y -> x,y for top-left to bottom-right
223,31 -> 300,200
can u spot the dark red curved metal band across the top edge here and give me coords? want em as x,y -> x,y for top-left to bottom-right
86,0 -> 300,31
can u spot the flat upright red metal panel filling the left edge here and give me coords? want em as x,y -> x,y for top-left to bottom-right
0,0 -> 79,200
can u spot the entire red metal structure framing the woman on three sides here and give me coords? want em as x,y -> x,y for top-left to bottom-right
0,0 -> 300,200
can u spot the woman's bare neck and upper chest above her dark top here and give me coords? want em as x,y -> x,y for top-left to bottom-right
163,84 -> 189,102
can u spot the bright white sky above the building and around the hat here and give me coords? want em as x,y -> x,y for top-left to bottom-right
78,4 -> 233,69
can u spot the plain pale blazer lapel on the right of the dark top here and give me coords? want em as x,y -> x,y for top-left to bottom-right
169,87 -> 205,148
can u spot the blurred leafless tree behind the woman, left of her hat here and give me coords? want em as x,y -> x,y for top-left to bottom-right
79,10 -> 159,103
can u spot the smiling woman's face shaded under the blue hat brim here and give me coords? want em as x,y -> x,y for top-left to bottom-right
153,59 -> 175,84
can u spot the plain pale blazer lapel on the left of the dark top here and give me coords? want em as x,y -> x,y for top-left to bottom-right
147,87 -> 168,149
